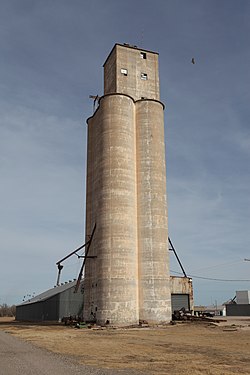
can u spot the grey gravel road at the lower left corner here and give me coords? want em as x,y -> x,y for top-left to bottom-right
0,331 -> 141,375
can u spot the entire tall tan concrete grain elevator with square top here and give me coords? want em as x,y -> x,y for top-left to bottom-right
84,44 -> 171,325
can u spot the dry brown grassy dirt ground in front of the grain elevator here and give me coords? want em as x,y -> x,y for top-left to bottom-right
0,317 -> 250,375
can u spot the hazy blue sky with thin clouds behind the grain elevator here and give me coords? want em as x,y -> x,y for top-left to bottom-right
0,0 -> 250,304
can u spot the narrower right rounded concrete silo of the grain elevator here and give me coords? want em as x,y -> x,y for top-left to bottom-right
135,100 -> 171,323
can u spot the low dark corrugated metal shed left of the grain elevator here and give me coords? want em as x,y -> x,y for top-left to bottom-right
16,281 -> 83,321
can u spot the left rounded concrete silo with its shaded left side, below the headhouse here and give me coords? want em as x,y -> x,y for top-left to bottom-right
84,94 -> 138,325
